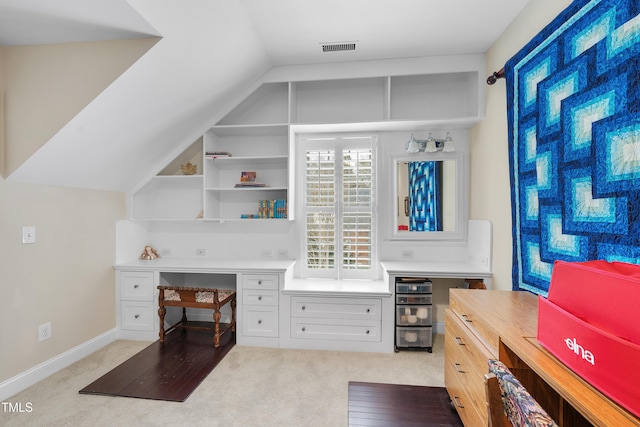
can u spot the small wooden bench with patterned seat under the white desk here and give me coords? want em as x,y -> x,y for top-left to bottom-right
158,286 -> 236,348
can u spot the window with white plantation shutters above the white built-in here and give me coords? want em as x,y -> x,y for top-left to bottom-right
301,136 -> 377,279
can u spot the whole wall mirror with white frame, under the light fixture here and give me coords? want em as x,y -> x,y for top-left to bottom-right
393,156 -> 464,240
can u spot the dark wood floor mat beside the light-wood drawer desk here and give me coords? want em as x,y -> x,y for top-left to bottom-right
349,381 -> 462,427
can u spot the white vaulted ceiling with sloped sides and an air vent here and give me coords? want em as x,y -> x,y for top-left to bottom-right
0,0 -> 528,191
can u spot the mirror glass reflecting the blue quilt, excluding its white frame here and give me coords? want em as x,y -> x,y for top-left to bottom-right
397,160 -> 456,232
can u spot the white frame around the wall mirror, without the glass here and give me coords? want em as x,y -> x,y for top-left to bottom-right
390,151 -> 469,241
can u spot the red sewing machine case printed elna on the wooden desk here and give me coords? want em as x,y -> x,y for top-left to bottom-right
538,261 -> 640,417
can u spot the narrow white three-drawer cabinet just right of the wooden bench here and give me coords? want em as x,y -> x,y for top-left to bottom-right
238,274 -> 279,347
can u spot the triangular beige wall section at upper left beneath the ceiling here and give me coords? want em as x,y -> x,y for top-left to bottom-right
0,38 -> 159,177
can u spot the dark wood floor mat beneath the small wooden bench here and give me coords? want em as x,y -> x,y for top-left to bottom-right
80,329 -> 236,402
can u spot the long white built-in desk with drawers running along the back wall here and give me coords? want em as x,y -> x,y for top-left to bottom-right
115,257 -> 491,353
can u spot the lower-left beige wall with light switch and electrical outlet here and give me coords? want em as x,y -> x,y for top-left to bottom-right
0,178 -> 125,382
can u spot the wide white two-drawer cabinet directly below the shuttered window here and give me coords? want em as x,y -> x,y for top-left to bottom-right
291,296 -> 382,342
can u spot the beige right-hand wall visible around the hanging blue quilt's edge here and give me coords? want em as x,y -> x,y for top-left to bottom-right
469,0 -> 571,290
